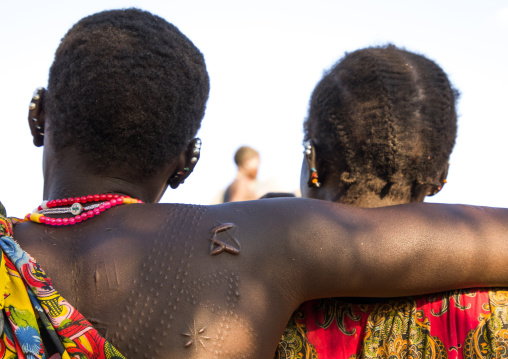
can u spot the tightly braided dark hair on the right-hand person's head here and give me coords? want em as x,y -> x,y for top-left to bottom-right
304,45 -> 457,202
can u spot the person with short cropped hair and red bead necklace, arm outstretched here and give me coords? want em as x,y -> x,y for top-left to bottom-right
4,9 -> 508,359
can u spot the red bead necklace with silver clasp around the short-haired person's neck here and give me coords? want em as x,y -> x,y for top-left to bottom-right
25,194 -> 144,226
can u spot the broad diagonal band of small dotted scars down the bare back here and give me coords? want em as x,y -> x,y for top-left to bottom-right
114,205 -> 205,359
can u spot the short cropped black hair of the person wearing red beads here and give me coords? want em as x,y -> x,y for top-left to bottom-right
46,9 -> 209,175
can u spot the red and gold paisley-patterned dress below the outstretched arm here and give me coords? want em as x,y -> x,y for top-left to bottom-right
275,289 -> 508,359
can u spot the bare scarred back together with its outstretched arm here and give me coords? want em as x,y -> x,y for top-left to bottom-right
11,198 -> 508,358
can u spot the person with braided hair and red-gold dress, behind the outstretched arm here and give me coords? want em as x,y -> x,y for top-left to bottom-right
276,45 -> 508,359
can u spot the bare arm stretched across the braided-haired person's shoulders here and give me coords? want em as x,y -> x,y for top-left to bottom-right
230,198 -> 508,301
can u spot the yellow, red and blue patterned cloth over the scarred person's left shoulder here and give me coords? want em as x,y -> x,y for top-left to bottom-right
0,207 -> 125,359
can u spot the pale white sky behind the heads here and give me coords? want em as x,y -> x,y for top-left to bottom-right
0,0 -> 508,216
